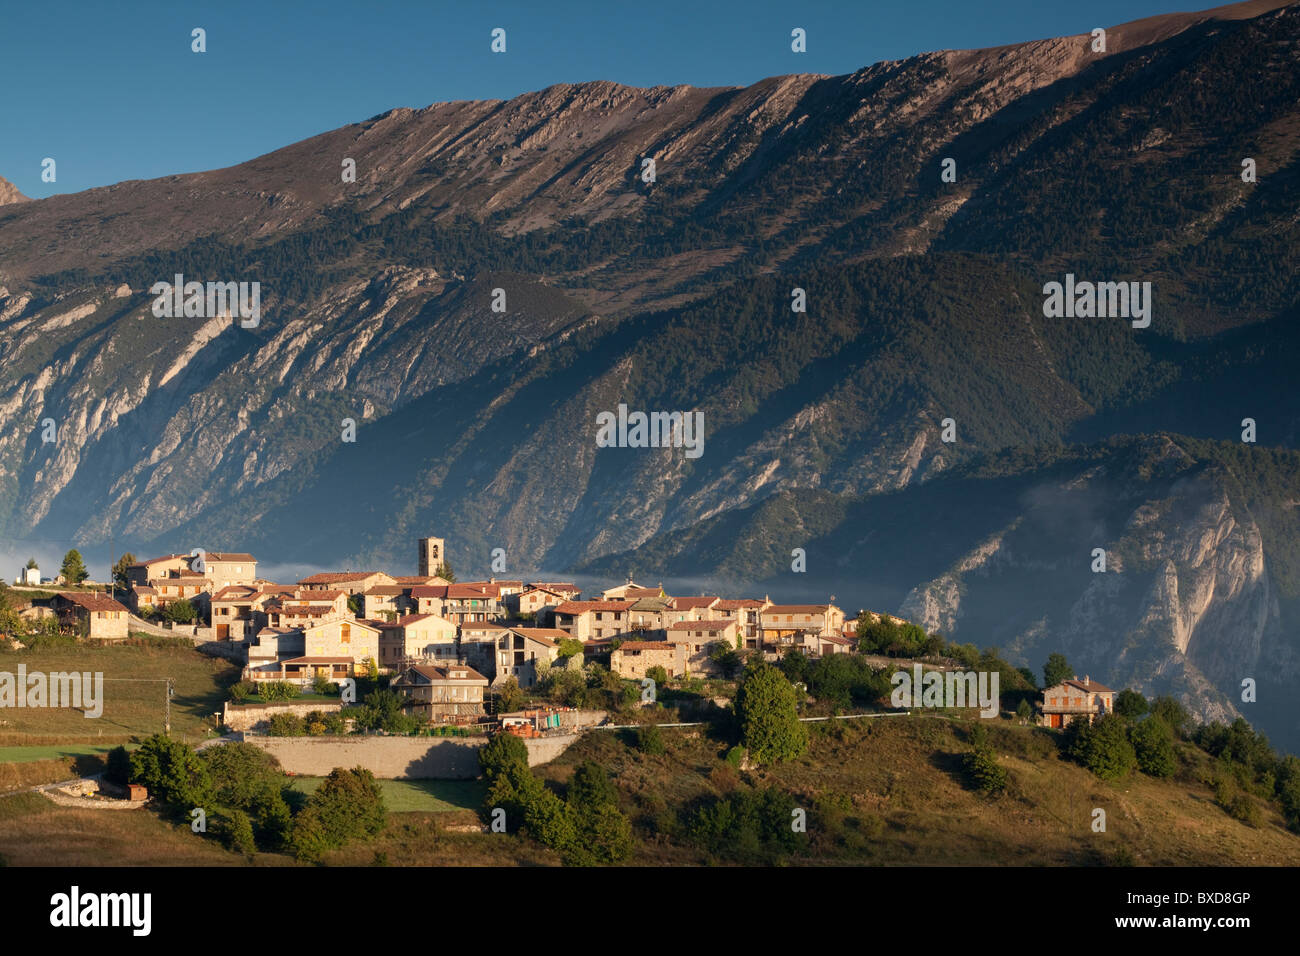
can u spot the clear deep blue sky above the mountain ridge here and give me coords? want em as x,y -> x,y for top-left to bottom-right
0,0 -> 1190,198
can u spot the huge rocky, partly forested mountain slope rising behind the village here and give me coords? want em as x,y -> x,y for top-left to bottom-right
0,3 -> 1300,749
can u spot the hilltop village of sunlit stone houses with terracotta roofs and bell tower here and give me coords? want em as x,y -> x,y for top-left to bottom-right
7,537 -> 1114,727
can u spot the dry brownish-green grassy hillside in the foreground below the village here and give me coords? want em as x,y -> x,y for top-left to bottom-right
0,717 -> 1300,866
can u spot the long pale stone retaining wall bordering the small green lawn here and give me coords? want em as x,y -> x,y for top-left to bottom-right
244,734 -> 580,780
